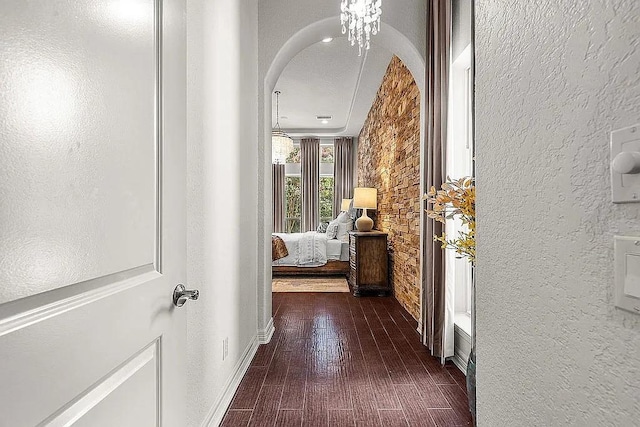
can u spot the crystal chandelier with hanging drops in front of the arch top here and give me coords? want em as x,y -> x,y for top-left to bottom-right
340,0 -> 382,56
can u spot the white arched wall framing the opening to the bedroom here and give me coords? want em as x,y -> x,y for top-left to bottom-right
258,0 -> 426,334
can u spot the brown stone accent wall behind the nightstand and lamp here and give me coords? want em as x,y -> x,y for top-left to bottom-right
358,56 -> 421,320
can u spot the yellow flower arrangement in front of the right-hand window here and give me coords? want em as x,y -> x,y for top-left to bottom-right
423,177 -> 476,264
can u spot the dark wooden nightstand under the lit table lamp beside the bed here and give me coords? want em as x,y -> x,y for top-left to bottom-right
349,230 -> 391,296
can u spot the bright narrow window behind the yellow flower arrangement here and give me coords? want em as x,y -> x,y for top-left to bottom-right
445,45 -> 474,334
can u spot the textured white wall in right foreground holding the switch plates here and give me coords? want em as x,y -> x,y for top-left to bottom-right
475,0 -> 640,427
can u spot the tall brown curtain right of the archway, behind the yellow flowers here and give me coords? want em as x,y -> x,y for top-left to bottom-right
422,0 -> 454,362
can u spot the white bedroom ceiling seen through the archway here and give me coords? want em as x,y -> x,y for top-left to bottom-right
272,37 -> 393,138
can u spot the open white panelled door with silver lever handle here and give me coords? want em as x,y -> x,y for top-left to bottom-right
0,0 -> 189,427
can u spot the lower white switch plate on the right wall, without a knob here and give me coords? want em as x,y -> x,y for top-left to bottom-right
613,236 -> 640,314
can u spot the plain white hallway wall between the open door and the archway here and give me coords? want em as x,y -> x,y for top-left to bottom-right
187,0 -> 258,426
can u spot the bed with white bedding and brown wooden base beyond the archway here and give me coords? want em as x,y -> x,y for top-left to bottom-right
272,231 -> 349,276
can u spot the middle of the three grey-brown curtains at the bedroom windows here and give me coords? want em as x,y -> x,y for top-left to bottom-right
300,138 -> 320,232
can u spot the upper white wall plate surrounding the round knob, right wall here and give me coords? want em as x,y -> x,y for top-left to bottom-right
609,123 -> 640,203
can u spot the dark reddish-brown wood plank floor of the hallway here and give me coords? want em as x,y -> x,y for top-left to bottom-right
222,293 -> 472,427
